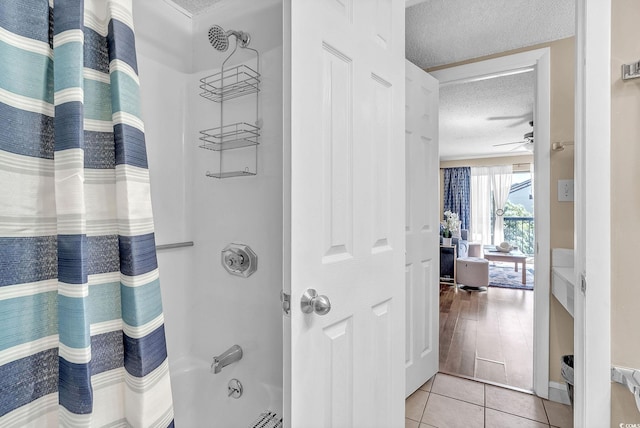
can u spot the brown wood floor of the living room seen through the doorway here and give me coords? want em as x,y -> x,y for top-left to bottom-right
440,284 -> 533,390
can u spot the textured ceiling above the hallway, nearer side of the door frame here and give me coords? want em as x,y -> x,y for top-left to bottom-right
406,0 -> 575,68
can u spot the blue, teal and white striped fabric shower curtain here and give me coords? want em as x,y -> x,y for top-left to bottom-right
0,0 -> 173,427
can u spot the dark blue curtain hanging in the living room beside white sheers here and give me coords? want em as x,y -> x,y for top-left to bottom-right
442,166 -> 471,229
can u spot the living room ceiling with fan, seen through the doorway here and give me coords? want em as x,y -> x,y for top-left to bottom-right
440,71 -> 535,160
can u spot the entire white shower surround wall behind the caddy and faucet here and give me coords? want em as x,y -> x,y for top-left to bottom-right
134,0 -> 283,427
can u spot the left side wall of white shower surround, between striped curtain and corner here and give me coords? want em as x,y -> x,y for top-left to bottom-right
133,0 -> 193,366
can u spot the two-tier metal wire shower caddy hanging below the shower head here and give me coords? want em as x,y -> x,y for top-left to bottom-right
199,57 -> 260,178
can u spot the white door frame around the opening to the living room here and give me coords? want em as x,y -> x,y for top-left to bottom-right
430,48 -> 551,398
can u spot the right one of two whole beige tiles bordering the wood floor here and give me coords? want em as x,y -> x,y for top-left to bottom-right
485,385 -> 549,424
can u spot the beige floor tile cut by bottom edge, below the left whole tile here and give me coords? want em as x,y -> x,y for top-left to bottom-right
422,392 -> 484,428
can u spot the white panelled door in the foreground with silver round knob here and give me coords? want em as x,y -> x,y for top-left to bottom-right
284,0 -> 405,428
